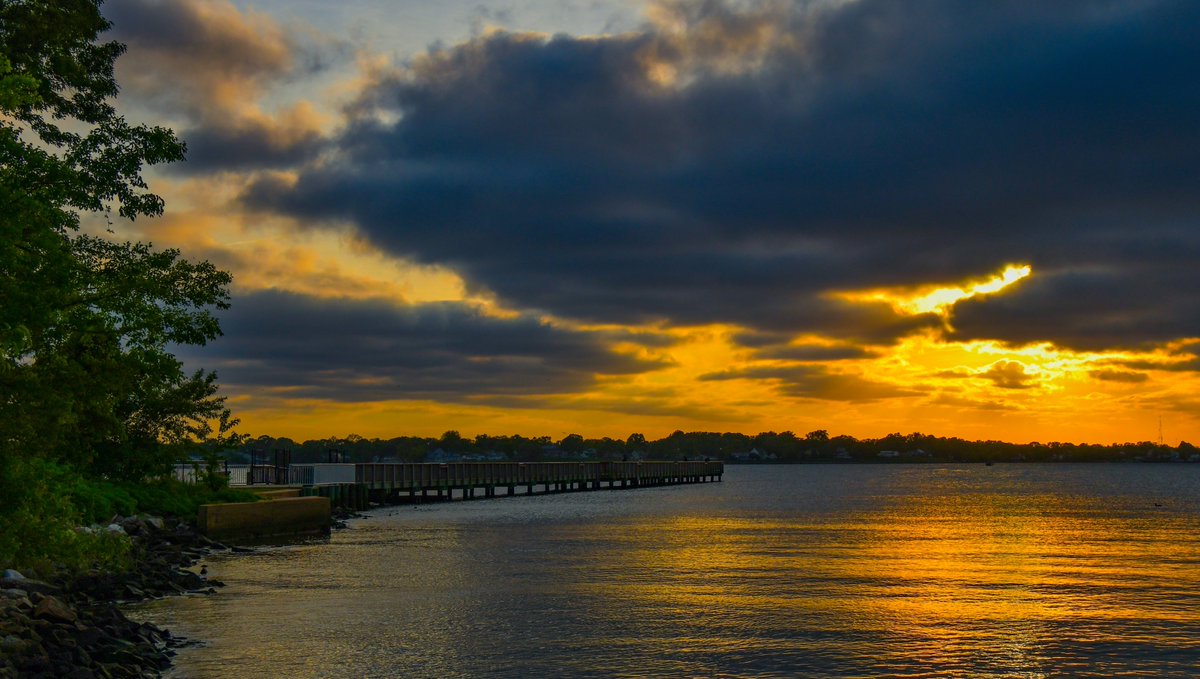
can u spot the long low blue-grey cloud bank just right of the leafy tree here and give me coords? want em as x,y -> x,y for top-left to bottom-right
185,292 -> 662,402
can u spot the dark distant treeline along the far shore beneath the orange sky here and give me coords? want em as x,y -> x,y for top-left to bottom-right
227,429 -> 1200,463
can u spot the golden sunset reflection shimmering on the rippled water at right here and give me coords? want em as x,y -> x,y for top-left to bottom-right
566,470 -> 1200,677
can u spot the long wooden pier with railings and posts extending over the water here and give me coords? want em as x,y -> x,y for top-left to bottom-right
304,461 -> 725,509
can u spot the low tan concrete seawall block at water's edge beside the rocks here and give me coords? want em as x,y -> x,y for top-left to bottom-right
196,498 -> 330,540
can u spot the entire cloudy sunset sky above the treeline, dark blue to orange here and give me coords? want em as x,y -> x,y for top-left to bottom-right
103,0 -> 1200,444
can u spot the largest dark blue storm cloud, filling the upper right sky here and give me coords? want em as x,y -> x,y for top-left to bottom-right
246,0 -> 1200,348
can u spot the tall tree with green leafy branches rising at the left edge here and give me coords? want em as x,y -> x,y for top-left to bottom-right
0,0 -> 230,491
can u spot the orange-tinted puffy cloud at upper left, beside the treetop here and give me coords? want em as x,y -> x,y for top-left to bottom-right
104,0 -> 346,173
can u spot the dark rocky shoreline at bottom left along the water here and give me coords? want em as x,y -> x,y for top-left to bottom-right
0,517 -> 240,679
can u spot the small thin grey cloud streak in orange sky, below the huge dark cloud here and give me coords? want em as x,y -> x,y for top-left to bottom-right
700,365 -> 920,402
